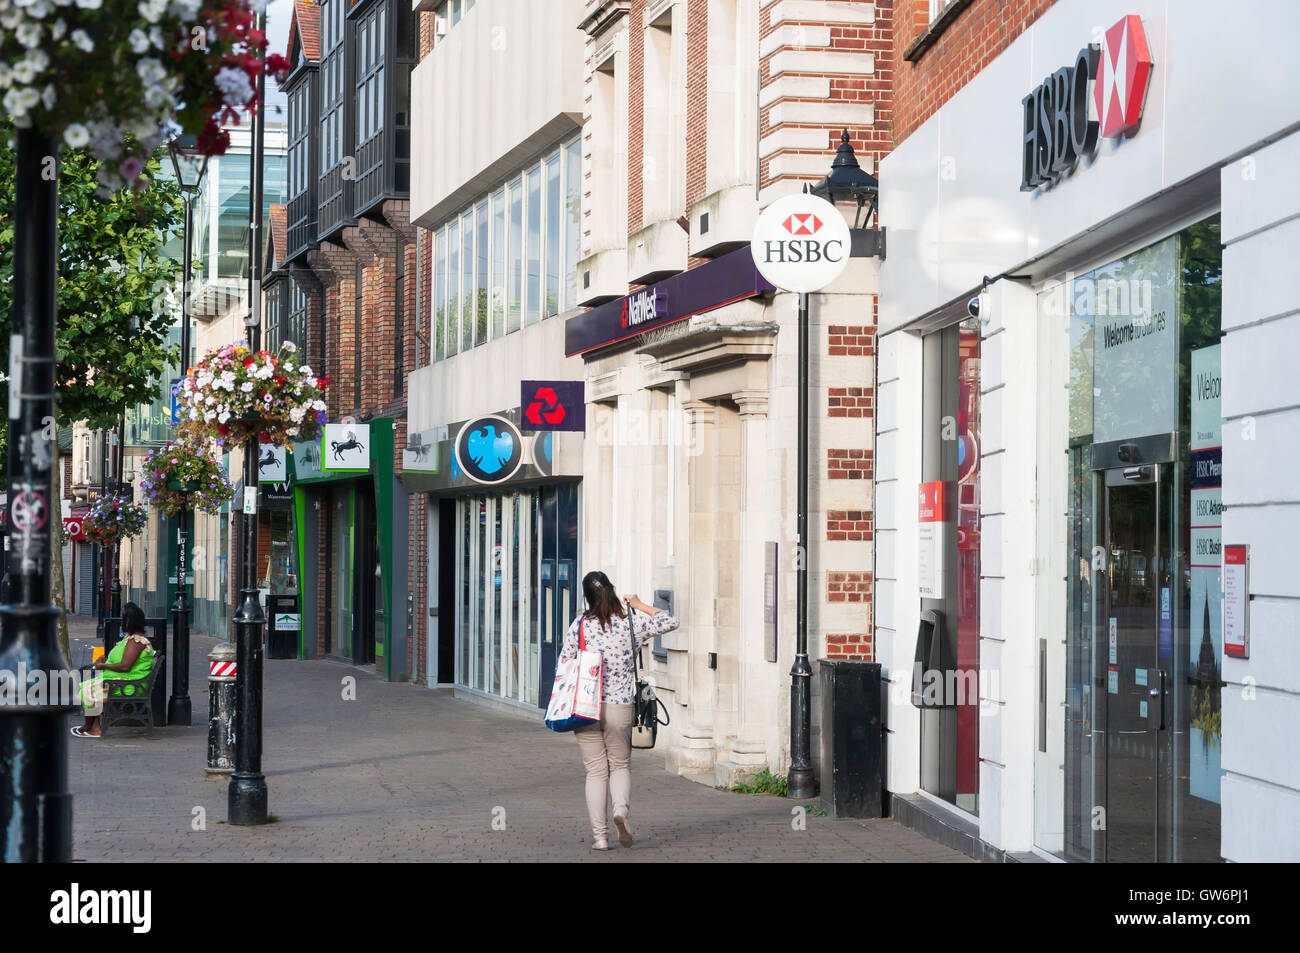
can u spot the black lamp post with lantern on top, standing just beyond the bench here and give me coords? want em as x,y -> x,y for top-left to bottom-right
166,135 -> 208,727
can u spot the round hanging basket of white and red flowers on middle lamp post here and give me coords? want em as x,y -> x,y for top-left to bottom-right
178,342 -> 329,447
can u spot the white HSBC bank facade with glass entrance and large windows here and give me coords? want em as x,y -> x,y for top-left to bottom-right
875,0 -> 1300,862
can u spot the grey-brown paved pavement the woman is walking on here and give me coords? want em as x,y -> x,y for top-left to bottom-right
69,621 -> 969,863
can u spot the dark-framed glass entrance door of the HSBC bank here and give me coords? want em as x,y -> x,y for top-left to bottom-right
1097,464 -> 1173,863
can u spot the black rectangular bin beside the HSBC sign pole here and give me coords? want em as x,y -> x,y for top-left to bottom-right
818,659 -> 884,818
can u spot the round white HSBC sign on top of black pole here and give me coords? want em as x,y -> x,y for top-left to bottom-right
749,192 -> 852,293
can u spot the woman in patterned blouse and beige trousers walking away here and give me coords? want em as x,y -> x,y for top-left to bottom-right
556,572 -> 679,850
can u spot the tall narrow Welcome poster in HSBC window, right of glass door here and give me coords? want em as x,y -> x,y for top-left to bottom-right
1190,345 -> 1223,803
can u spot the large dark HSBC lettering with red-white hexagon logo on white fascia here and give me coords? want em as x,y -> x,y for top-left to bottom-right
1021,14 -> 1152,191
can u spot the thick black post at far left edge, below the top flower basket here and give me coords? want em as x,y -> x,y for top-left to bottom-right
0,127 -> 77,863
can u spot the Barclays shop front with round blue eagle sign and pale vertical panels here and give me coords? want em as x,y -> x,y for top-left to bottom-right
403,408 -> 582,709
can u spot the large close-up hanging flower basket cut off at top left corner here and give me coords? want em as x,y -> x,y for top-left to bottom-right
0,0 -> 290,190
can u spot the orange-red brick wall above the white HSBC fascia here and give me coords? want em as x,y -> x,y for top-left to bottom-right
893,0 -> 1060,143
